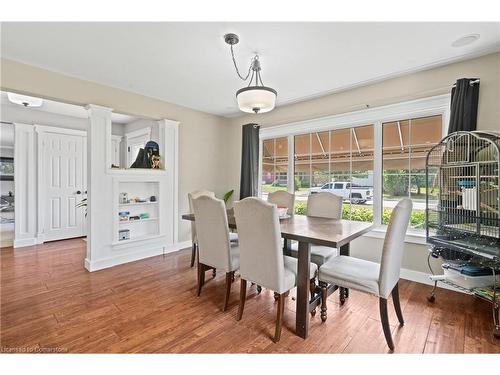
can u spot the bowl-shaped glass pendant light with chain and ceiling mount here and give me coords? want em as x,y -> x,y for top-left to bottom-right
224,34 -> 278,113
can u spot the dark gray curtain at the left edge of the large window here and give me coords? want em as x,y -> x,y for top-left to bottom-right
240,124 -> 259,199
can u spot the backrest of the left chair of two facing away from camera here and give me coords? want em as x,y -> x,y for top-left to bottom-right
193,195 -> 232,272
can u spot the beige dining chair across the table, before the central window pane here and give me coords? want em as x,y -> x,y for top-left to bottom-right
290,191 -> 342,267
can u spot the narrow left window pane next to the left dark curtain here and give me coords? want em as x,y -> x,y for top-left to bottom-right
261,137 -> 288,199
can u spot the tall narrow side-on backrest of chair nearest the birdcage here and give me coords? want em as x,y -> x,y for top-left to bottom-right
379,198 -> 413,298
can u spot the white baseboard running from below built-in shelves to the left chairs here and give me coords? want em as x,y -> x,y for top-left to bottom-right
85,241 -> 191,272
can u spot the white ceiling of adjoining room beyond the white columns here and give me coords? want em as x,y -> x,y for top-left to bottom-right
0,91 -> 137,124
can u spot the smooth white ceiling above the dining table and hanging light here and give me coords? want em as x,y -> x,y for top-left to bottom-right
1,22 -> 500,115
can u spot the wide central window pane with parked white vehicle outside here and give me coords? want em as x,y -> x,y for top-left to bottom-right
294,125 -> 373,221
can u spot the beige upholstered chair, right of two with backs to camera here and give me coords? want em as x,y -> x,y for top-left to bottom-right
234,197 -> 318,342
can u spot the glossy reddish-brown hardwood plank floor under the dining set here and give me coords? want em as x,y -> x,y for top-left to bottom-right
0,239 -> 500,353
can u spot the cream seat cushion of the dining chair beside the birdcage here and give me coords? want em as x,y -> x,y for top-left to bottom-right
318,255 -> 380,296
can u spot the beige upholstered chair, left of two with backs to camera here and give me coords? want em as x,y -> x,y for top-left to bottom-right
193,195 -> 240,311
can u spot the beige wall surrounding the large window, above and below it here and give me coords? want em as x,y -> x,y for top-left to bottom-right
228,53 -> 500,278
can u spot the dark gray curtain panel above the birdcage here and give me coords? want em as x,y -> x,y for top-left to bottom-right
448,78 -> 479,134
